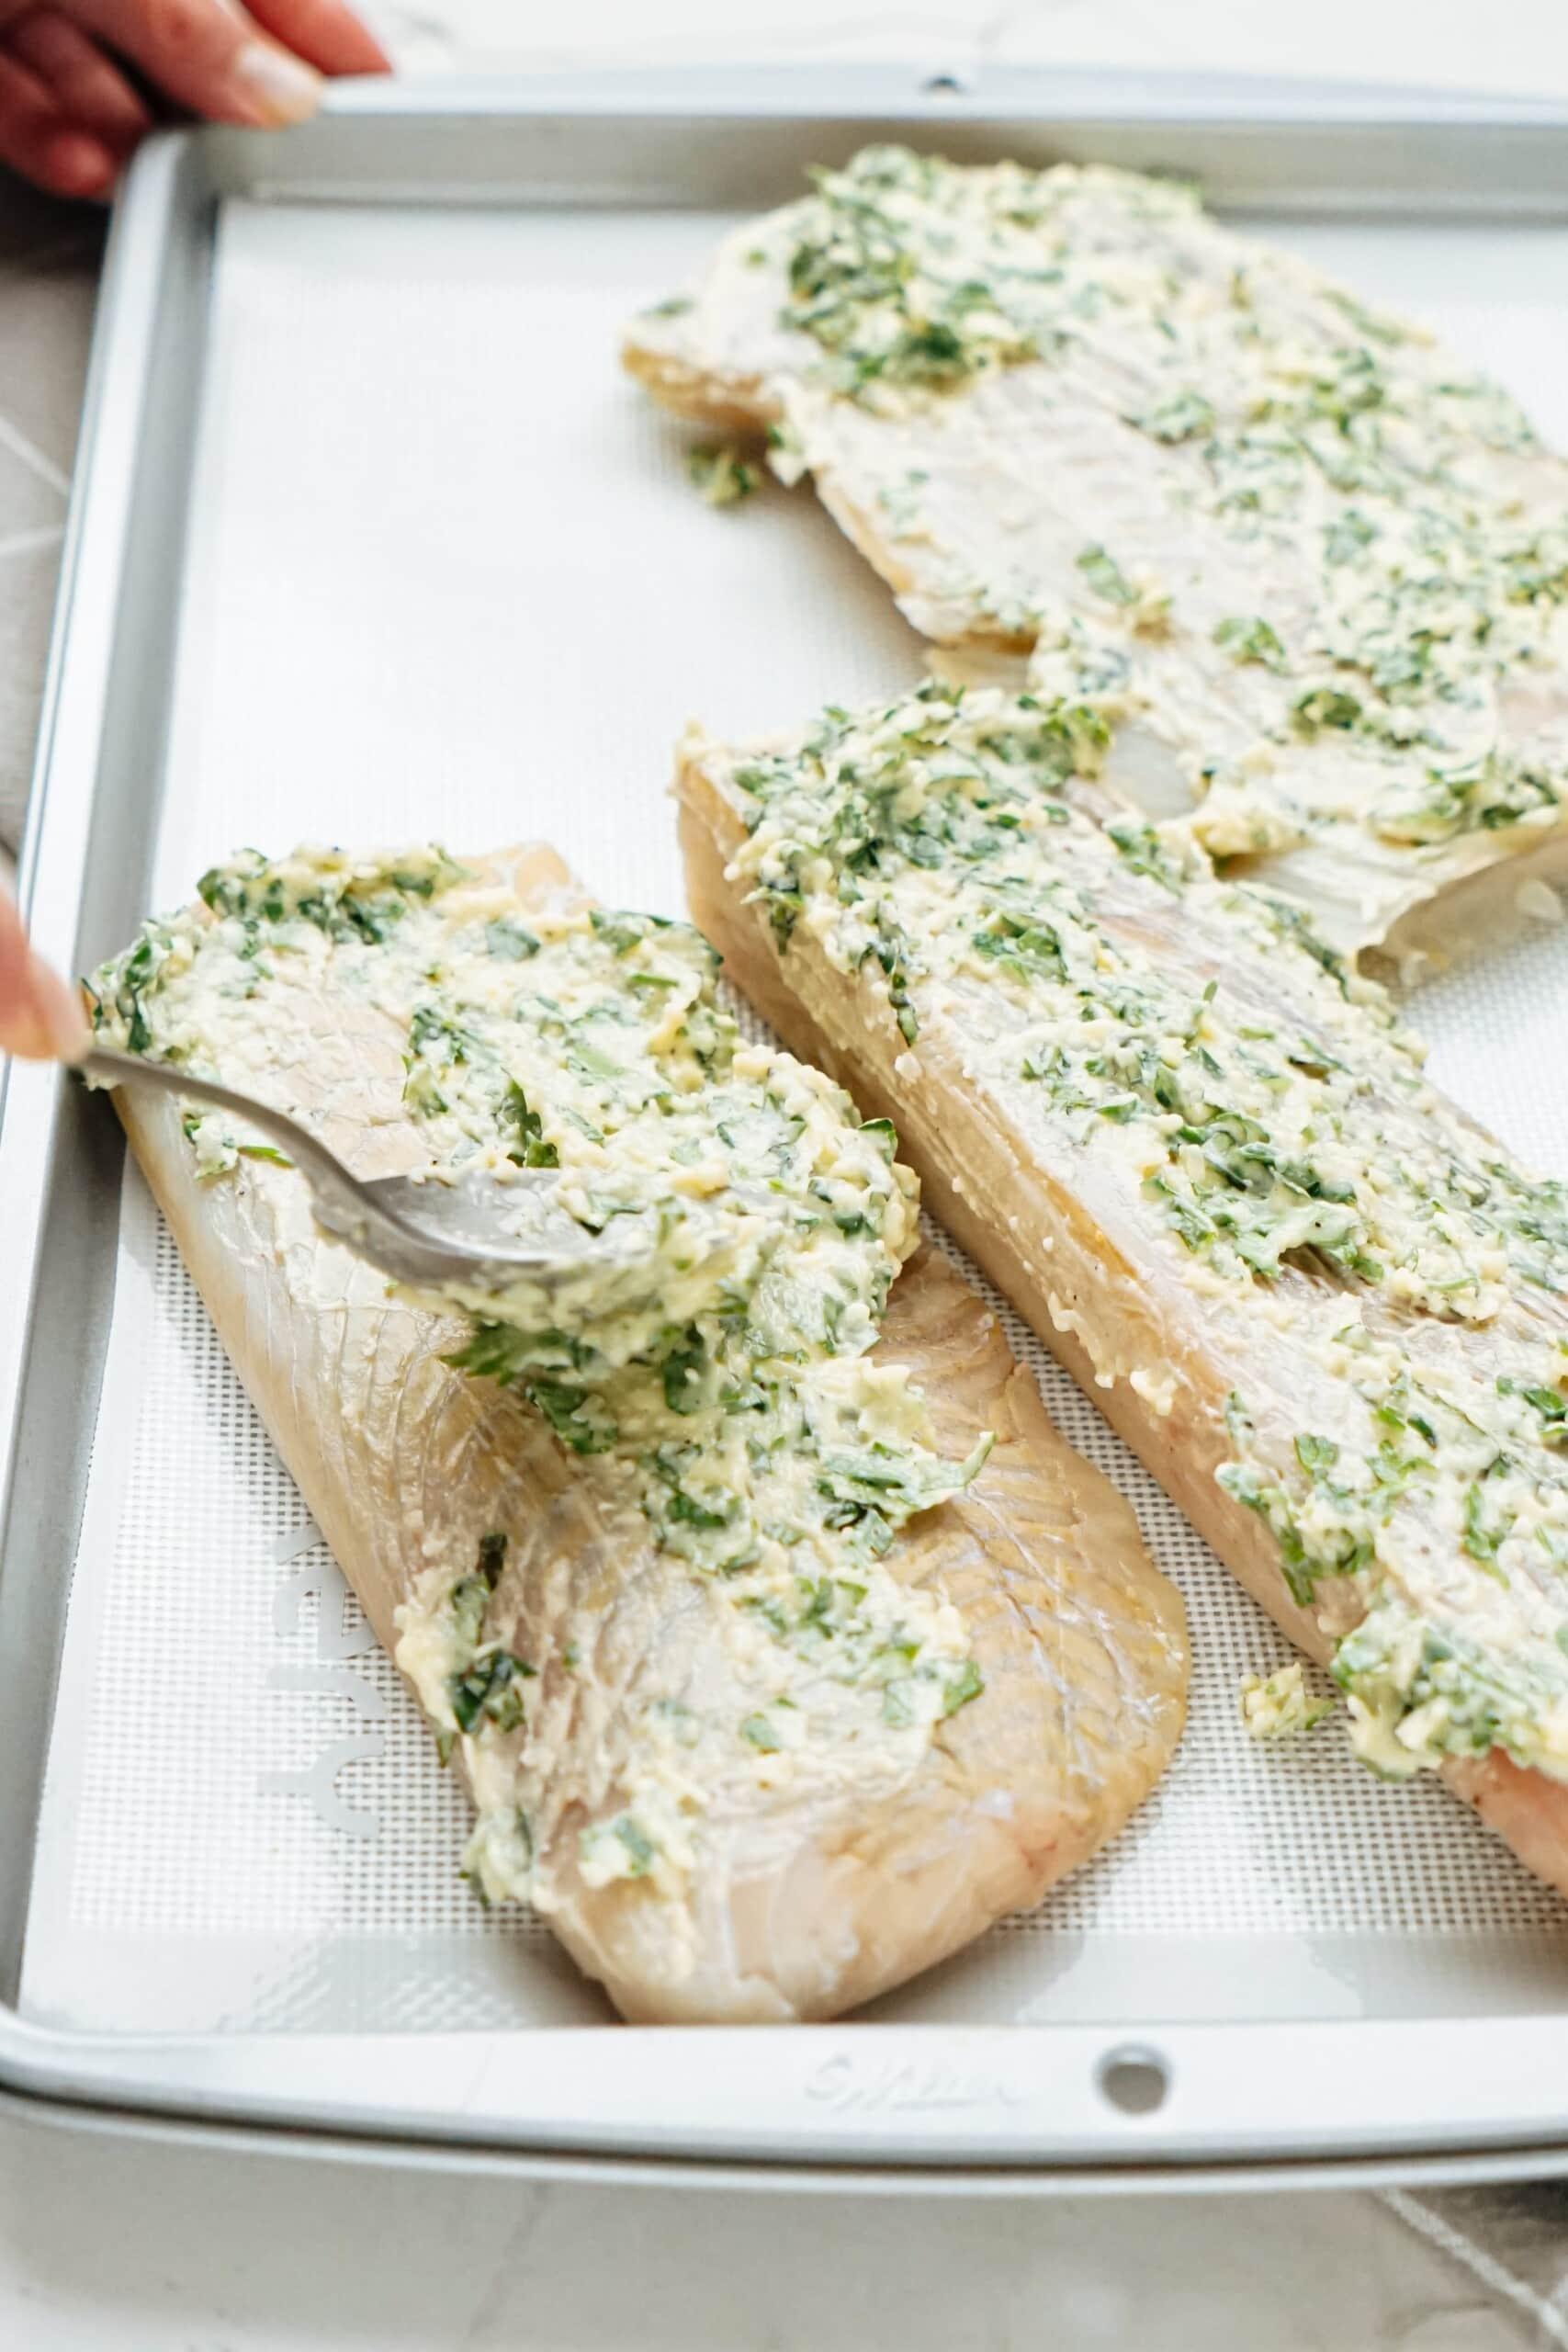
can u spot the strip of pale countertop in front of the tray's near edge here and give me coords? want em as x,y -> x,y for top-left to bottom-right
0,2124 -> 1540,2352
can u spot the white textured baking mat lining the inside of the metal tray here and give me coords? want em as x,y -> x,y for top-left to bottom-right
8,74 -> 1568,2145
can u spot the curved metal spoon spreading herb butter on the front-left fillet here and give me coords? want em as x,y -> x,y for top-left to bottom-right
75,1046 -> 709,1291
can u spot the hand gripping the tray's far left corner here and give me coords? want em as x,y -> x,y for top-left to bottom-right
0,0 -> 388,195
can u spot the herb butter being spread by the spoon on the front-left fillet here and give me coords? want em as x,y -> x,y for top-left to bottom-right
94,849 -> 987,1898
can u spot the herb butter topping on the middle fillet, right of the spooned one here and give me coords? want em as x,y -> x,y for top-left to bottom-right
724,687 -> 1568,1778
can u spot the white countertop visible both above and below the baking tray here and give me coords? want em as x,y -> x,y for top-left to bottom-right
0,0 -> 1568,2352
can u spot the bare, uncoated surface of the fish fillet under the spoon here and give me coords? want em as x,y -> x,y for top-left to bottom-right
115,849 -> 1187,2023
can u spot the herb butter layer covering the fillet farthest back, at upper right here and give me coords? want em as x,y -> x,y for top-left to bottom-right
644,148 -> 1568,944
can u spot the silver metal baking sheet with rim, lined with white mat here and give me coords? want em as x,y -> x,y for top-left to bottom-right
0,77 -> 1568,2168
